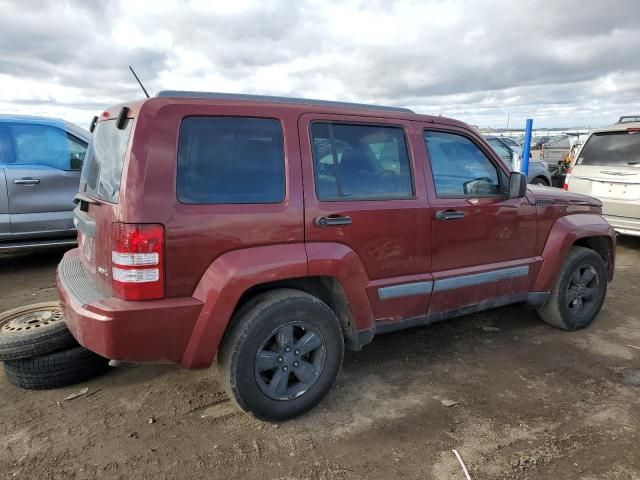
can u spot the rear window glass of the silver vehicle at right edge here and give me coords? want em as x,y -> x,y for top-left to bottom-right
578,131 -> 640,166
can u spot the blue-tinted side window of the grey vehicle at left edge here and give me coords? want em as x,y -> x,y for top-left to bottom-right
0,124 -> 87,170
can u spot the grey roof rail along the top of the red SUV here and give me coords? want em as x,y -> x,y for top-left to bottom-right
156,90 -> 414,113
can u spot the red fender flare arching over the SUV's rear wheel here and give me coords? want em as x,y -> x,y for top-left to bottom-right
181,242 -> 374,368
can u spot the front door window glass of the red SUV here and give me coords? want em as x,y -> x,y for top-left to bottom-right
424,131 -> 501,198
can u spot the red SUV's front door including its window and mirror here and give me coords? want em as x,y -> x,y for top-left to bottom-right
423,126 -> 540,316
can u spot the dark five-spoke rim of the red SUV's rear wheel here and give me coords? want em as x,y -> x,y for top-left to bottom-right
254,321 -> 327,400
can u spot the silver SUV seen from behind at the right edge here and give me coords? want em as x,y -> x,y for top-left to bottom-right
564,122 -> 640,236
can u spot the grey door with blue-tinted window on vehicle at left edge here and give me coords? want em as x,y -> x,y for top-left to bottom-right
4,123 -> 86,239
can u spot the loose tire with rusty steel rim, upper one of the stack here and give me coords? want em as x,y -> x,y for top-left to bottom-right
0,302 -> 78,361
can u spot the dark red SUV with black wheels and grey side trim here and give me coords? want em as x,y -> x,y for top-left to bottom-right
58,92 -> 615,420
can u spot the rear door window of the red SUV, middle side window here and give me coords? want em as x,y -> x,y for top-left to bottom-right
311,122 -> 413,201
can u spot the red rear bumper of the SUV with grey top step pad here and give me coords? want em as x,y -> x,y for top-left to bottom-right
56,248 -> 202,363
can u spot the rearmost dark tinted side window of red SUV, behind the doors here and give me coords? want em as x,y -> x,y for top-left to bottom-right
177,117 -> 285,204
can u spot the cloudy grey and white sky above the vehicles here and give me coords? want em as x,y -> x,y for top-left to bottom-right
0,0 -> 640,127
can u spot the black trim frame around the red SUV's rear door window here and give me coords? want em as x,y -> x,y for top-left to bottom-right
307,119 -> 417,203
